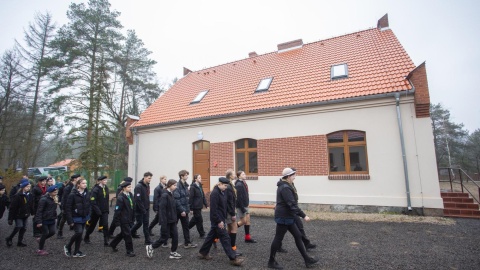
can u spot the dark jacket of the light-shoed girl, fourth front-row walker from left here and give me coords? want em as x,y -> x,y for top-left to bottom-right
64,188 -> 91,225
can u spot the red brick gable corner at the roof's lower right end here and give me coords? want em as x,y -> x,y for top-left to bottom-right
407,62 -> 430,118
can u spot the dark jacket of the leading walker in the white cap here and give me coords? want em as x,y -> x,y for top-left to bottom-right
275,179 -> 306,219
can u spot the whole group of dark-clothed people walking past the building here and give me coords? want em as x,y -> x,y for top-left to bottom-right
0,168 -> 318,269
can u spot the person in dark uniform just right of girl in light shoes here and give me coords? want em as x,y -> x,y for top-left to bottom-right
83,175 -> 110,247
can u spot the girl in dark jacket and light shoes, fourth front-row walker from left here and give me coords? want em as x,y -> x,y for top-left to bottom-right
63,179 -> 91,258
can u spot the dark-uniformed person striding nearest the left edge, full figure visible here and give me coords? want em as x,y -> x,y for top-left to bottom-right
5,180 -> 34,247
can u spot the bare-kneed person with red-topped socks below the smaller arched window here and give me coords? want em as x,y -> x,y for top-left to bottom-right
235,171 -> 257,243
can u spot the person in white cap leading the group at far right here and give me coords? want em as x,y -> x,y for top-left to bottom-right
268,168 -> 318,269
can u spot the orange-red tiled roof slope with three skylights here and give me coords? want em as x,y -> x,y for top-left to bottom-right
134,28 -> 415,127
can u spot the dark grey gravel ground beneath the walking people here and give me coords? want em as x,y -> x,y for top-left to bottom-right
0,209 -> 480,270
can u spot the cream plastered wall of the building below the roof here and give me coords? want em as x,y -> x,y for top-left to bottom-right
129,97 -> 443,208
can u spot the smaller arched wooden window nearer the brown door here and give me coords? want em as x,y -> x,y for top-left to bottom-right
235,139 -> 258,175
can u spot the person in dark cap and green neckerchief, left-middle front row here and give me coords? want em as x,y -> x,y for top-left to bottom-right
110,181 -> 135,257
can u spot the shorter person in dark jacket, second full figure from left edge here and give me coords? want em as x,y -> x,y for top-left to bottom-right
35,185 -> 58,256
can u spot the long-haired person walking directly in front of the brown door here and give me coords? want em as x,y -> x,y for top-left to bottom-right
188,174 -> 208,239
